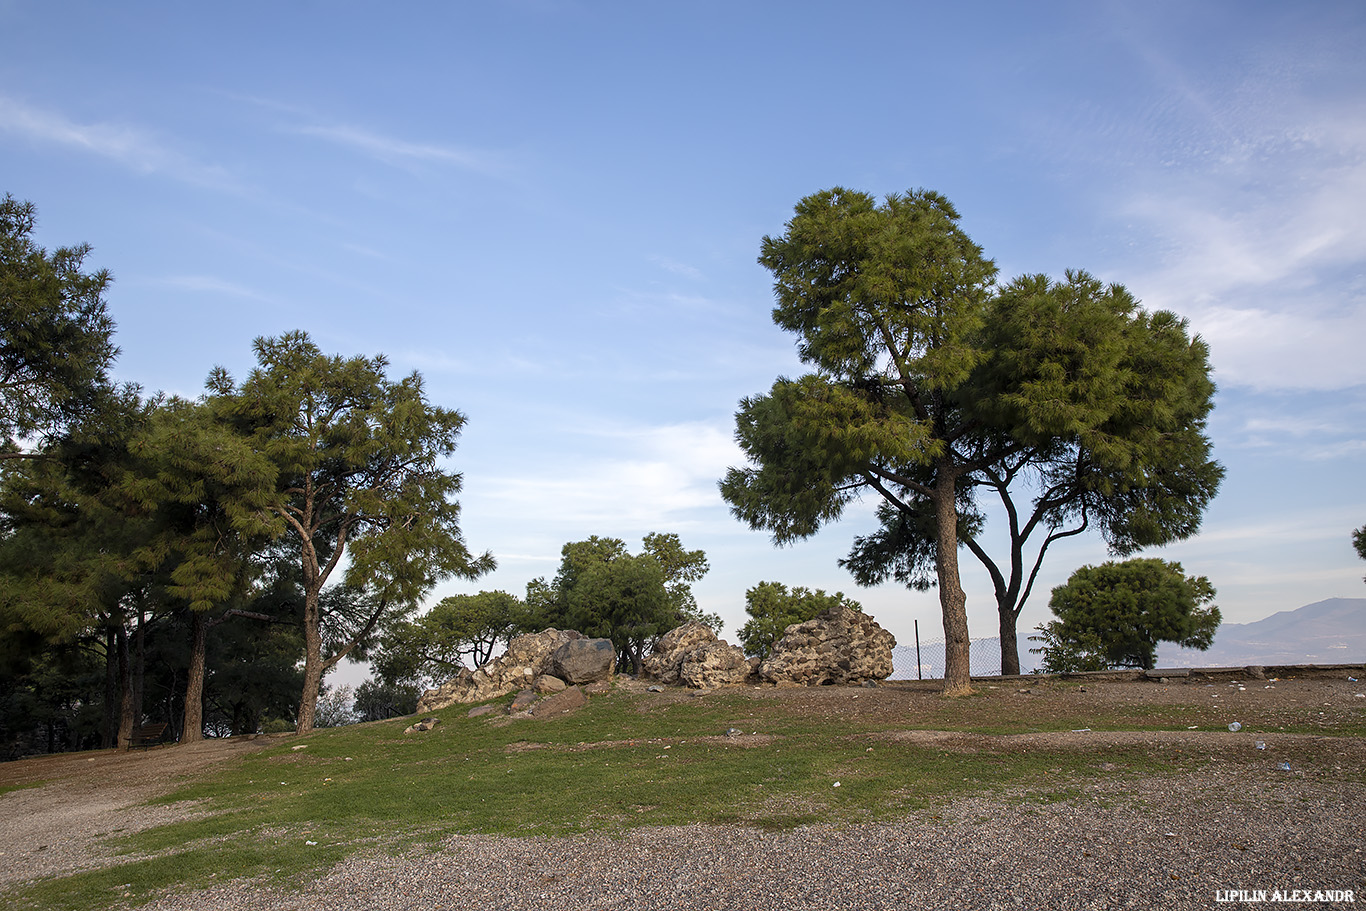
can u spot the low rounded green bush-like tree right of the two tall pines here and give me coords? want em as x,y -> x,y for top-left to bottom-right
1040,559 -> 1220,671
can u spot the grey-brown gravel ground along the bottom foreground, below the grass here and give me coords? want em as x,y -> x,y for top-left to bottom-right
130,766 -> 1366,911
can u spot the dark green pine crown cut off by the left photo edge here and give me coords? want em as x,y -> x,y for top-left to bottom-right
0,194 -> 117,458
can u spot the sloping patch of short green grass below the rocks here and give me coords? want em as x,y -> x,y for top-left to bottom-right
0,692 -> 1360,911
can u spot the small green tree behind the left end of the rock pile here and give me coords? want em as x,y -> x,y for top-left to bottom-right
373,591 -> 527,684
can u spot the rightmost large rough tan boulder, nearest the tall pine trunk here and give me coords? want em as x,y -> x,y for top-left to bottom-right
759,606 -> 896,686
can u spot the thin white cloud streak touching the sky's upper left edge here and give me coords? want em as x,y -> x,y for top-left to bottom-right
0,96 -> 236,188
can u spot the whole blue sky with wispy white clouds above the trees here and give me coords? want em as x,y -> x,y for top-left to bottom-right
0,0 -> 1366,664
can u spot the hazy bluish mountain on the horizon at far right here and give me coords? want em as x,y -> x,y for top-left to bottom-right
1157,598 -> 1366,668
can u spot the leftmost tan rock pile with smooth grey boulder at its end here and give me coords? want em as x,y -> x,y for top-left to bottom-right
418,630 -> 616,713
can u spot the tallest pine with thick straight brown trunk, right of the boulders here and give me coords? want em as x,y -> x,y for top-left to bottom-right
721,188 -> 996,692
